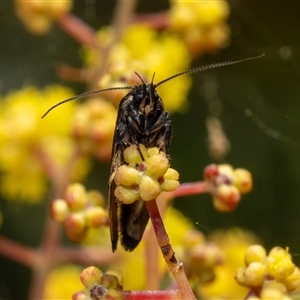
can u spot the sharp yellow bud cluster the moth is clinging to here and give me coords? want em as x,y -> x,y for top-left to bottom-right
114,144 -> 179,204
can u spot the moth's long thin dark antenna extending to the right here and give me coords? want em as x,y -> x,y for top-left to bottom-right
155,53 -> 265,88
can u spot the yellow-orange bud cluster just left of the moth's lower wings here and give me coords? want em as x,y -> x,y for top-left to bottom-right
51,183 -> 108,242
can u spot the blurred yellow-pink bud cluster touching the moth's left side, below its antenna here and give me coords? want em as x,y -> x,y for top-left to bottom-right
72,98 -> 117,161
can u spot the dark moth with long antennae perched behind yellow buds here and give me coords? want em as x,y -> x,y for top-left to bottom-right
42,54 -> 264,252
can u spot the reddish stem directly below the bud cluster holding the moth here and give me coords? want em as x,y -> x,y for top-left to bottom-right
146,199 -> 196,300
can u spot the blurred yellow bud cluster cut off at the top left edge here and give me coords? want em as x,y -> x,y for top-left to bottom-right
15,0 -> 73,35
